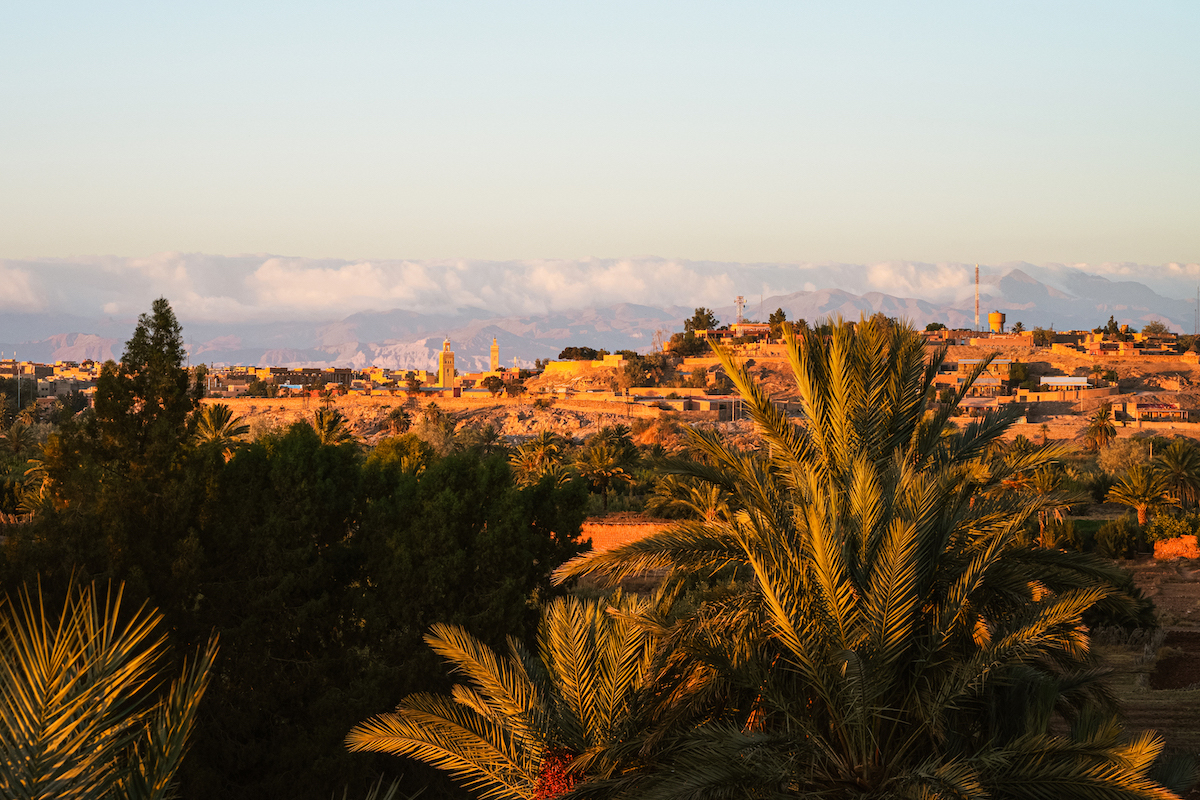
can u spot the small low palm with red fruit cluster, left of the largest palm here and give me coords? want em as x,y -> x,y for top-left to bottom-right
346,595 -> 653,800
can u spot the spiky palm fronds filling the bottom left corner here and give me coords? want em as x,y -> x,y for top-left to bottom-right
0,587 -> 217,800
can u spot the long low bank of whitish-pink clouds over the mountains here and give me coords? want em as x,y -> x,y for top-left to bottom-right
0,253 -> 1200,323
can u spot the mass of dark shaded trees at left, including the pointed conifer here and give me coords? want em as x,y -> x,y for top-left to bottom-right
0,300 -> 588,799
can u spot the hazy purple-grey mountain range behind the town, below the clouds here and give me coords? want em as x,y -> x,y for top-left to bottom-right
0,259 -> 1196,371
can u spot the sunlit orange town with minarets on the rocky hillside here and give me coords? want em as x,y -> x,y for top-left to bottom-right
0,308 -> 1200,438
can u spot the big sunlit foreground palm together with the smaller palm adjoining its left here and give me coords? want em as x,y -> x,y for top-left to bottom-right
347,320 -> 1189,800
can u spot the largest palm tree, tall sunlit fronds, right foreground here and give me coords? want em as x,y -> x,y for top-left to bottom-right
558,320 -> 1171,798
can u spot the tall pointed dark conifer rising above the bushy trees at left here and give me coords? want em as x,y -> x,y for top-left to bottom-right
17,297 -> 206,604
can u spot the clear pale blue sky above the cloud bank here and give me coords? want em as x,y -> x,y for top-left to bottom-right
0,0 -> 1200,264
